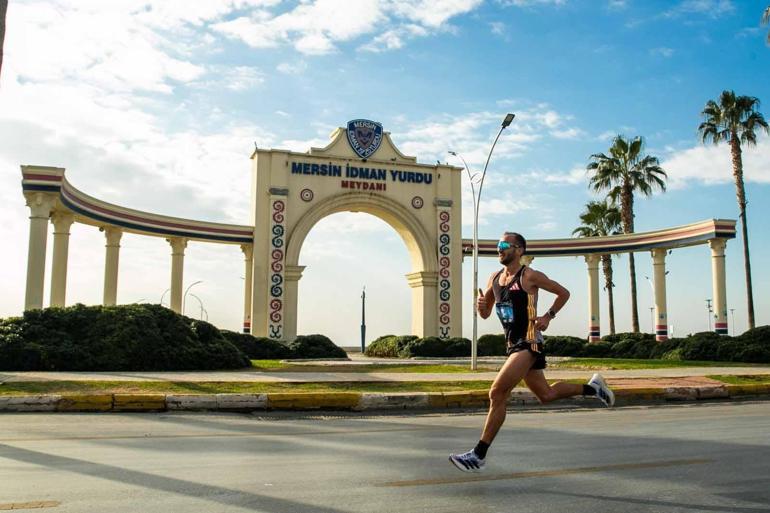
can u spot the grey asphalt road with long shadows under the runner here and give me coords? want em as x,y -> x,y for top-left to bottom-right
0,402 -> 770,513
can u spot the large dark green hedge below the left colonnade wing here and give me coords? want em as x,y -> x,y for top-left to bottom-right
0,304 -> 347,371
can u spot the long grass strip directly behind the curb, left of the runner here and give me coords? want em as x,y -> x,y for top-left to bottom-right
0,381 -> 492,396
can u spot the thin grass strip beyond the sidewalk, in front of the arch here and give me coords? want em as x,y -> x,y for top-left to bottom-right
251,360 -> 500,374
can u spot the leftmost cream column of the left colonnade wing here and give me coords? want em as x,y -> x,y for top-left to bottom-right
24,192 -> 55,310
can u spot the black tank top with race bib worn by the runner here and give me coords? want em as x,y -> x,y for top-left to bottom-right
492,266 -> 536,344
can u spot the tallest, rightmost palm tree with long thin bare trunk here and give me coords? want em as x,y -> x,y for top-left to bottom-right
698,91 -> 768,328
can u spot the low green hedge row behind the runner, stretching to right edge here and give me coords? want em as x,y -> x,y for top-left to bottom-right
365,326 -> 770,363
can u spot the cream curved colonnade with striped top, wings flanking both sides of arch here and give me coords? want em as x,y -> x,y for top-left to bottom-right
21,166 -> 735,341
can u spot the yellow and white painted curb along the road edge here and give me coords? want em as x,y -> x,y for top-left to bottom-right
0,384 -> 770,413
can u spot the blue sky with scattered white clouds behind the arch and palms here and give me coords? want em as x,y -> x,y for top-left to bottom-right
0,0 -> 770,345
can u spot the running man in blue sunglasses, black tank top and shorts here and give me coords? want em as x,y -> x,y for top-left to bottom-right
449,232 -> 615,472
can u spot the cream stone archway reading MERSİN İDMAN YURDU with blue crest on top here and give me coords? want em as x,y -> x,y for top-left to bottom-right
251,120 -> 462,340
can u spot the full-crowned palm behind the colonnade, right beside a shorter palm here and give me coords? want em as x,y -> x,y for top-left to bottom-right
587,135 -> 666,333
